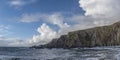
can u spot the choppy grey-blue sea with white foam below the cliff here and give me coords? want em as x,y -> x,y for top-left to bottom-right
0,46 -> 120,60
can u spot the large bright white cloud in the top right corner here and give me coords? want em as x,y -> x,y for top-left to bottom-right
79,0 -> 120,17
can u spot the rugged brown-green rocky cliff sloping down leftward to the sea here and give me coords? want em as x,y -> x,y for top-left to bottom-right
34,22 -> 120,48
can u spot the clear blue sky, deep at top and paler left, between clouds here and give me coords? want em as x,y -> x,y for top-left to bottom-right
0,0 -> 83,46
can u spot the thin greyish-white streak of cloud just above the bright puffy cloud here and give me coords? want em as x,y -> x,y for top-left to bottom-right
19,13 -> 69,28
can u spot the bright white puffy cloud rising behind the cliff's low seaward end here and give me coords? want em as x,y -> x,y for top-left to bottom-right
29,23 -> 57,44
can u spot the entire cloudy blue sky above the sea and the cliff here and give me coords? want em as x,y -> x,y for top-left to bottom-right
0,0 -> 120,47
